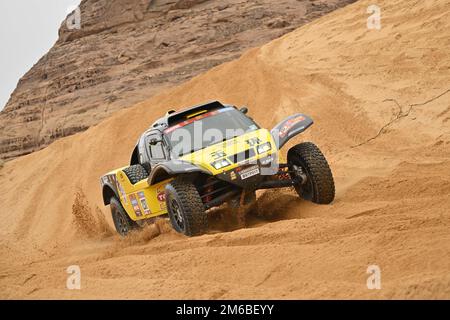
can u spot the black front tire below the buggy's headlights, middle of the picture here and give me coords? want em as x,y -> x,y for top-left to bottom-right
166,178 -> 208,237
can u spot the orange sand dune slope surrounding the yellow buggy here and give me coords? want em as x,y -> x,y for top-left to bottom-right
0,0 -> 450,299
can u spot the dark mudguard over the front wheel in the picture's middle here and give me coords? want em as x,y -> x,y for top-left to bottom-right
148,160 -> 210,185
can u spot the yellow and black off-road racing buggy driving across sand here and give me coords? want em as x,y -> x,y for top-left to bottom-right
101,101 -> 335,236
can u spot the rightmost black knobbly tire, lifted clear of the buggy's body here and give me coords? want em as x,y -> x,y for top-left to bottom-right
287,142 -> 335,204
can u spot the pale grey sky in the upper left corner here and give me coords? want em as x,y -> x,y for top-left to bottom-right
0,0 -> 80,110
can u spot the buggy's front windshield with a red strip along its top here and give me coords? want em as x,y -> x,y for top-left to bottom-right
165,108 -> 259,157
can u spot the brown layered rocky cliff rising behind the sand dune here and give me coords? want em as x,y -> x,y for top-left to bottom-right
0,0 -> 354,159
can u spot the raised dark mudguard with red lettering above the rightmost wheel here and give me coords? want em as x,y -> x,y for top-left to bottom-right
270,113 -> 314,149
